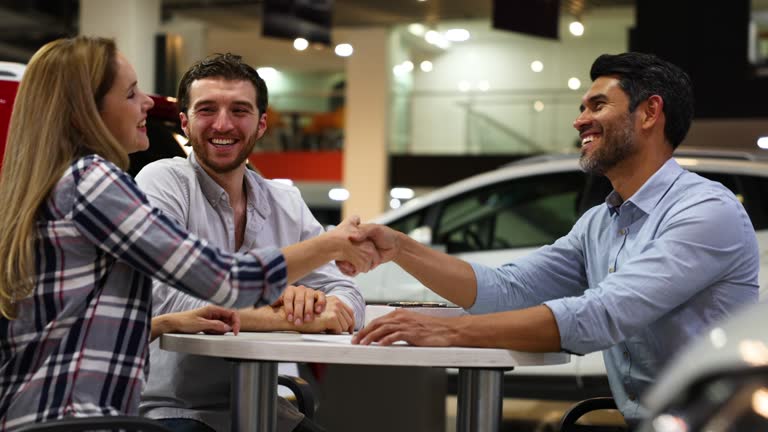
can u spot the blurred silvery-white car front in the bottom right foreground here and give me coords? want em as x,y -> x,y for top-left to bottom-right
640,303 -> 768,432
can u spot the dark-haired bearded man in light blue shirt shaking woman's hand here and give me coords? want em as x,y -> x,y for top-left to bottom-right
352,53 -> 759,425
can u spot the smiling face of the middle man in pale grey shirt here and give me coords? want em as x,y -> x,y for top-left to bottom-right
181,78 -> 267,174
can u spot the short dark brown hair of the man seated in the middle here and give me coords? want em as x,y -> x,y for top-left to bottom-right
176,53 -> 269,115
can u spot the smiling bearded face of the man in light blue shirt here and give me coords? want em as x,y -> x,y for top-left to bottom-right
573,76 -> 637,175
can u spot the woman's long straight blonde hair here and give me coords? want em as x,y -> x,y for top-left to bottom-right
0,36 -> 128,319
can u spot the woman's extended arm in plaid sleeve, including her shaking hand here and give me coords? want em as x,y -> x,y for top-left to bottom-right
71,158 -> 373,306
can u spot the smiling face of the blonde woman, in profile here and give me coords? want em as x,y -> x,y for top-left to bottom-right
100,54 -> 154,153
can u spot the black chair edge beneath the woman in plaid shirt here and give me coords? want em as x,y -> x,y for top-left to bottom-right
18,416 -> 173,432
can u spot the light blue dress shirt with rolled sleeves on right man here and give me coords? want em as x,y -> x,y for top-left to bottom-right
469,159 -> 759,422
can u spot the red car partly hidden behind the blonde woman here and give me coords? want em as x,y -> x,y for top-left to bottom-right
0,62 -> 186,175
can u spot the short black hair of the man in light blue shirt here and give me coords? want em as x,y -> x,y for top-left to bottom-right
589,52 -> 693,149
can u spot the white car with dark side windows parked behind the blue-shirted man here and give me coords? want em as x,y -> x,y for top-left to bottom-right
357,150 -> 768,399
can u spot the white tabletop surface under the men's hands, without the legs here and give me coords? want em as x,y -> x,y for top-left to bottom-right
160,332 -> 570,368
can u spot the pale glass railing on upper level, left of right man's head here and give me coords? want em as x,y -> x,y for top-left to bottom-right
390,89 -> 581,155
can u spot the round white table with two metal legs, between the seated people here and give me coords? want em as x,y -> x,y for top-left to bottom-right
160,332 -> 570,432
